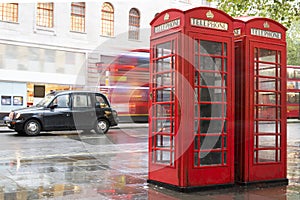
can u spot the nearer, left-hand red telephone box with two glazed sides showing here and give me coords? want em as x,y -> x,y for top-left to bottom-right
148,7 -> 234,191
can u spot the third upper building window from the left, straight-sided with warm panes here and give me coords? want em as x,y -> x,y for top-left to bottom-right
71,2 -> 85,32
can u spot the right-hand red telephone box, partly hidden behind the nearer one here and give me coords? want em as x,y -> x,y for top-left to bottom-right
234,17 -> 288,185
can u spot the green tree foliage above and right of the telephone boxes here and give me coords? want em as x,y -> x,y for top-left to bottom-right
208,0 -> 300,65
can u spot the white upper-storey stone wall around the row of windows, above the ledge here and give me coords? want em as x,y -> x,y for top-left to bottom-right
0,0 -> 211,56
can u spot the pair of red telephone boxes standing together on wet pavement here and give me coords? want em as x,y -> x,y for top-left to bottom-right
148,7 -> 286,192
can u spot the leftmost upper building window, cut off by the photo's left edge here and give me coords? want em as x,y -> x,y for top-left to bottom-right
0,3 -> 18,22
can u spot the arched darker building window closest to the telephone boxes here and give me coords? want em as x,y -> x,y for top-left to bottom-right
128,8 -> 140,40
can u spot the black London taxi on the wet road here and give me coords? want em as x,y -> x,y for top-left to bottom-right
4,91 -> 119,135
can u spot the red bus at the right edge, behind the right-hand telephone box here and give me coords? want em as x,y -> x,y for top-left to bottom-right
287,66 -> 300,119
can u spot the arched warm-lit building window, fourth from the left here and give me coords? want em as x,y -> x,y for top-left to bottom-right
101,3 -> 114,37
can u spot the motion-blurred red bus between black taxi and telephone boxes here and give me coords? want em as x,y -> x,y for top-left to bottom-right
98,49 -> 150,122
